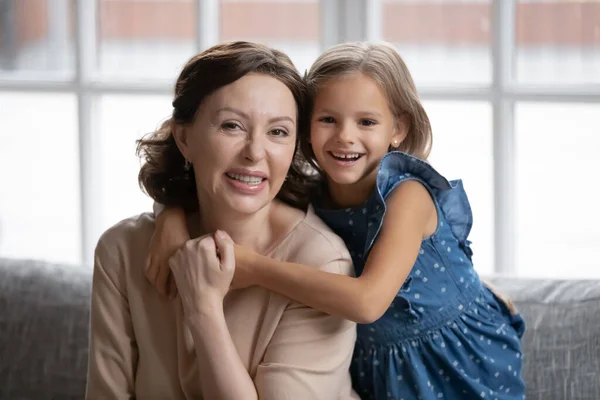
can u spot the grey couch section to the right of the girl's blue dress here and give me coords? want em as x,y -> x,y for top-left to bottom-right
490,278 -> 600,400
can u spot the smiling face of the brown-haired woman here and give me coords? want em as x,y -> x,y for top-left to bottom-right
175,73 -> 297,214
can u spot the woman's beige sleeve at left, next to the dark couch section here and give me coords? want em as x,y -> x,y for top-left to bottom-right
86,234 -> 138,400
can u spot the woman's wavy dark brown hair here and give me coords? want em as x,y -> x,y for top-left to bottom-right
137,41 -> 309,211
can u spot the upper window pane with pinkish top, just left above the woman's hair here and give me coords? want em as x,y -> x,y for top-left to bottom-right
97,0 -> 196,81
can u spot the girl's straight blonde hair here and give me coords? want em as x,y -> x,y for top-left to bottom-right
301,42 -> 432,170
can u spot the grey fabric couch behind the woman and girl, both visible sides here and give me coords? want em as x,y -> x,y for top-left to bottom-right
0,258 -> 600,400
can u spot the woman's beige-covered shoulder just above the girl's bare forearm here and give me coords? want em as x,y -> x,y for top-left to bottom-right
279,206 -> 353,275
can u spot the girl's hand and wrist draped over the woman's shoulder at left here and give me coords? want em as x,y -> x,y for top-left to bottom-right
145,208 -> 190,298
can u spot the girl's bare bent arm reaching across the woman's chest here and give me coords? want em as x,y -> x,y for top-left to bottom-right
236,181 -> 437,324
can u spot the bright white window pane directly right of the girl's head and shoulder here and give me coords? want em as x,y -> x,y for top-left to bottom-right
424,101 -> 494,274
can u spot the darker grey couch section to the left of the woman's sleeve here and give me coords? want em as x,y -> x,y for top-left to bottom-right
0,258 -> 92,400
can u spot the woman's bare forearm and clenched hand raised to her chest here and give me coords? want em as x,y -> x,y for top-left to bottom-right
170,233 -> 258,400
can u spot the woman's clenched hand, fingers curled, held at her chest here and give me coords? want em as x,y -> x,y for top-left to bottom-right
169,231 -> 235,316
